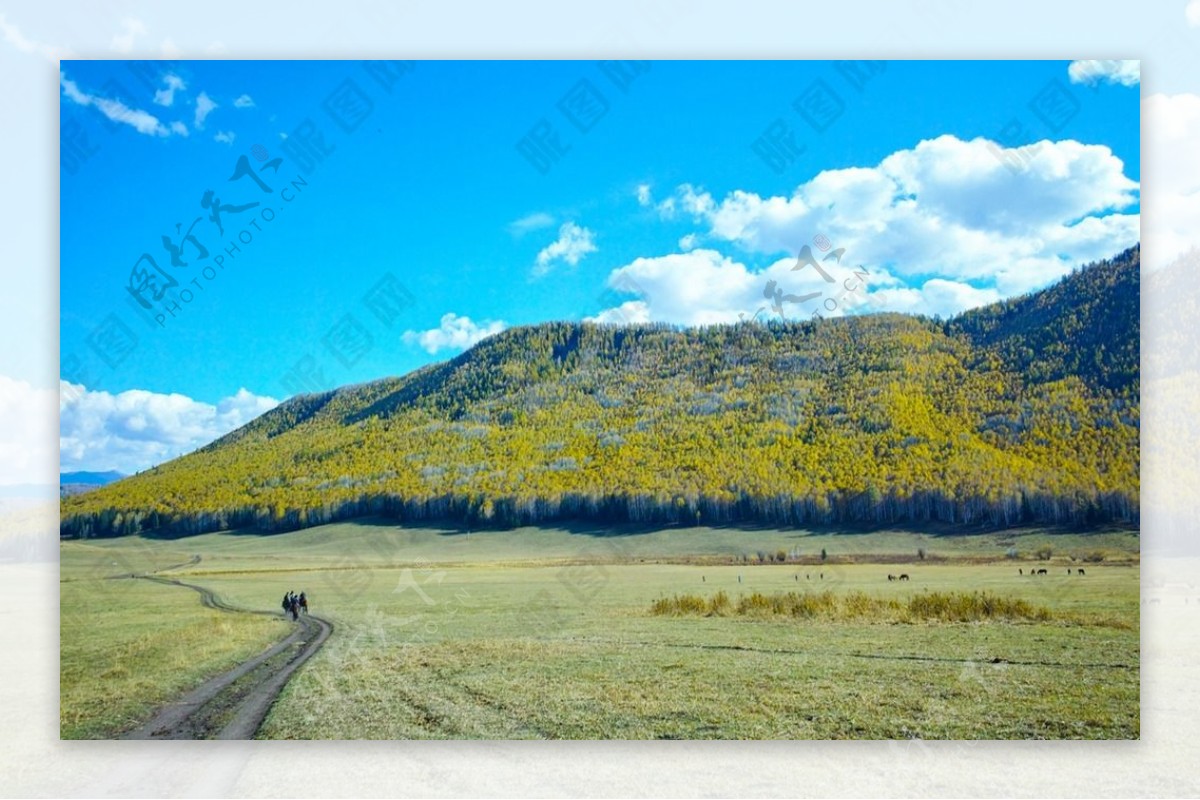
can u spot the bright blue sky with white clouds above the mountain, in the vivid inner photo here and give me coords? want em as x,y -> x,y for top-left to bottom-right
60,61 -> 1140,471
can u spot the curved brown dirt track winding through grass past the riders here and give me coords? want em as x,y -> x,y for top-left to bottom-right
121,573 -> 334,739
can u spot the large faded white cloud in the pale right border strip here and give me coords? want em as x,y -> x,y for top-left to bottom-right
1141,94 -> 1200,269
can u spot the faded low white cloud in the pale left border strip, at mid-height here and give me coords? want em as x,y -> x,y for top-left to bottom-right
0,375 -> 59,485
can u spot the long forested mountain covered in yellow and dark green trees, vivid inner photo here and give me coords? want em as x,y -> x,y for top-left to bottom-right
61,247 -> 1140,536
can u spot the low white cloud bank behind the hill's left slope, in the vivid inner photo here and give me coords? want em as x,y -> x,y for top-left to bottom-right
59,380 -> 278,473
